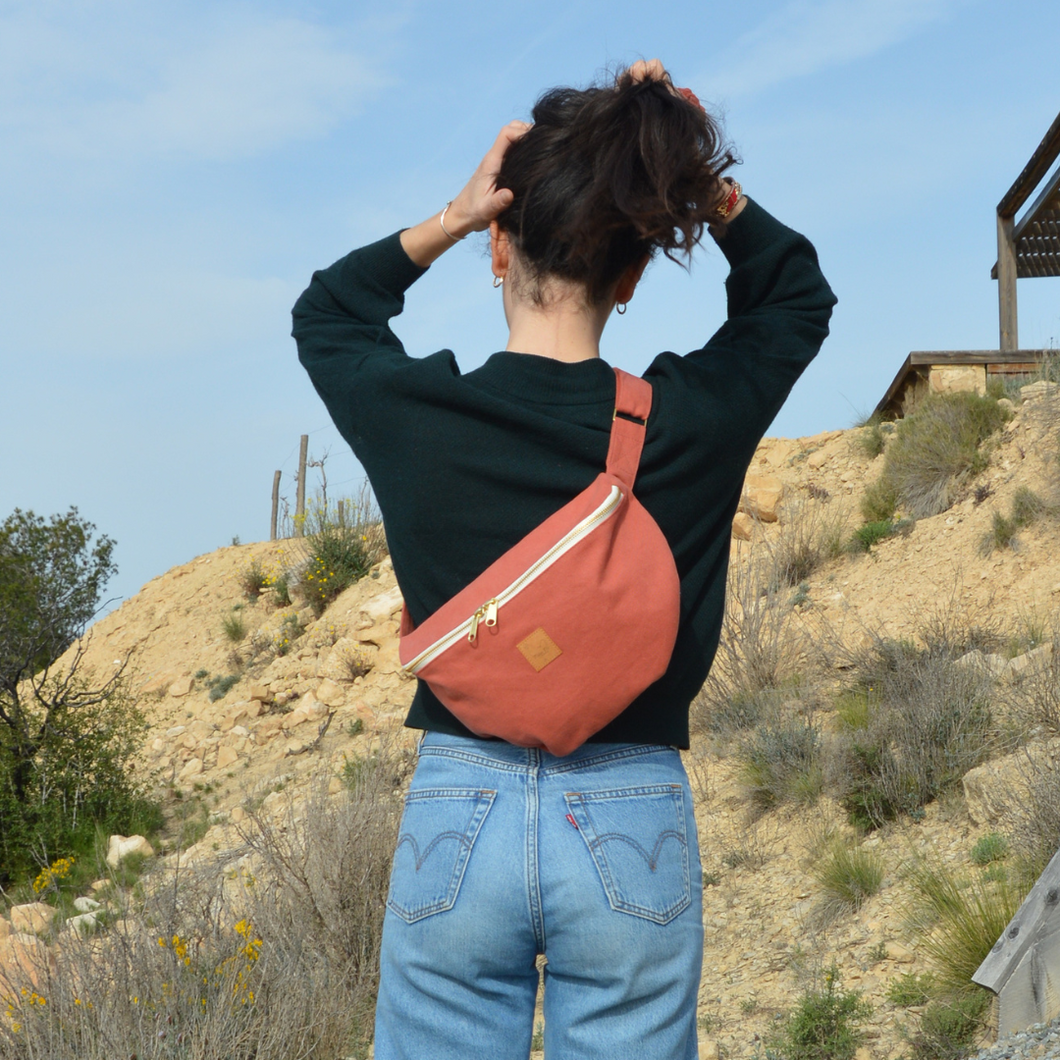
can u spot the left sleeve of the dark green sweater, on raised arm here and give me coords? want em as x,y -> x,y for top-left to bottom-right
292,232 -> 426,439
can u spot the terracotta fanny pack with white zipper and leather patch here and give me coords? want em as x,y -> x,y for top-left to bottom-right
400,369 -> 681,755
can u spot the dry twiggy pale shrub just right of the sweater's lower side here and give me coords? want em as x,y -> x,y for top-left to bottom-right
692,548 -> 806,734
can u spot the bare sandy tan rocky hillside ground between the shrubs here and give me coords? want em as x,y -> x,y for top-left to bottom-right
2,383 -> 1060,1058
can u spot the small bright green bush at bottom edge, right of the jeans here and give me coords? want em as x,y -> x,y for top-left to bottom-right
769,965 -> 872,1060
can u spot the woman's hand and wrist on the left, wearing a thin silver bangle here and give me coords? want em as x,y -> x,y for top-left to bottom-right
401,122 -> 530,268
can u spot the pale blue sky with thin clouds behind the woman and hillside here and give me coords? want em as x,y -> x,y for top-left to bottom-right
0,0 -> 1060,610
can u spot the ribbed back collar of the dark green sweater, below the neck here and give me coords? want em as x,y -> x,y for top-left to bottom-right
464,350 -> 615,405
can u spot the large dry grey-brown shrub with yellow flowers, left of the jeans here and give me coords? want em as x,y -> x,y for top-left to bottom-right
0,754 -> 402,1060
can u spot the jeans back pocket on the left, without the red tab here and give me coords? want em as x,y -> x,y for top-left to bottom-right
387,788 -> 496,923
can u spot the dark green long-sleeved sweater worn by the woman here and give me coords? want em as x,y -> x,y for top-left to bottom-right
294,201 -> 835,747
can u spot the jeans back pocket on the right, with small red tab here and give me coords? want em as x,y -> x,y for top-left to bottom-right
565,784 -> 691,924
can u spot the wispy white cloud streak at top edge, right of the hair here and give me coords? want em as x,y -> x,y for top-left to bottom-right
702,0 -> 966,96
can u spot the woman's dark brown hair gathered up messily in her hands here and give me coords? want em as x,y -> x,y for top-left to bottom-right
497,72 -> 735,304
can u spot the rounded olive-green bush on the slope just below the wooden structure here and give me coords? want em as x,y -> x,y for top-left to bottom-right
862,393 -> 1008,523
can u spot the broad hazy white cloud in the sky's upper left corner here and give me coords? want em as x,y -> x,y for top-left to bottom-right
0,2 -> 385,160
